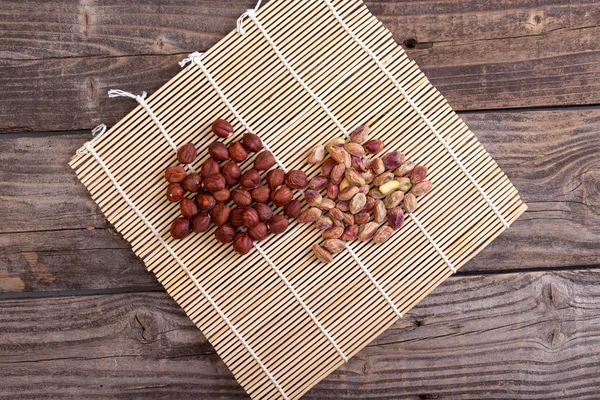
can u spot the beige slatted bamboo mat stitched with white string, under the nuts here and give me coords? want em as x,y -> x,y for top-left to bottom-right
71,0 -> 526,399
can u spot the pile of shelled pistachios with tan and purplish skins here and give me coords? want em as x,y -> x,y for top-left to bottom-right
297,126 -> 432,263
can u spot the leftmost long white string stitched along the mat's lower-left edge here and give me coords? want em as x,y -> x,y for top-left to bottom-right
77,130 -> 287,399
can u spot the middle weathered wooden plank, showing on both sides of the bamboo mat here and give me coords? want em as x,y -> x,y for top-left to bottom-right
0,109 -> 600,291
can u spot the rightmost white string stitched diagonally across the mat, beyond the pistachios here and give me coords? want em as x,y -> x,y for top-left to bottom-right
323,0 -> 509,228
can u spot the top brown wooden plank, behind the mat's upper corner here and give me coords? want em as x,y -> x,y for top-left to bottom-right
0,0 -> 600,132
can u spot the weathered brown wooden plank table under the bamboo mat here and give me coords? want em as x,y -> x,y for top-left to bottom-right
0,0 -> 600,399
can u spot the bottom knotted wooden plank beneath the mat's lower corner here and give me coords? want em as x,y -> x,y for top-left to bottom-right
0,270 -> 600,399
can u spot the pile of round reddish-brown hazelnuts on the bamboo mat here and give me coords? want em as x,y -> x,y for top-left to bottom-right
165,119 -> 308,255
